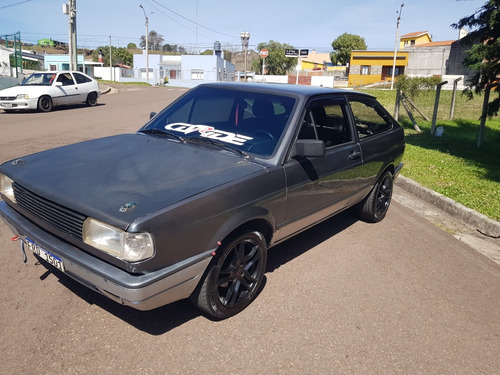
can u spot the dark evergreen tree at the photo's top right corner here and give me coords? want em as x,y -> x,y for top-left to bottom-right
451,0 -> 500,147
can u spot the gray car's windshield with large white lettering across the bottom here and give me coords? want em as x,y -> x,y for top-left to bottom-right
141,86 -> 296,157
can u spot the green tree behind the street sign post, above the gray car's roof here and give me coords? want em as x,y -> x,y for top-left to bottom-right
252,40 -> 297,75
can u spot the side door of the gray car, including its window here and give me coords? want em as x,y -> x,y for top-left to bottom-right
280,96 -> 362,238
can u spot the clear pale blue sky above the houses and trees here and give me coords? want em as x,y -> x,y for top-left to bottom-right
0,0 -> 486,53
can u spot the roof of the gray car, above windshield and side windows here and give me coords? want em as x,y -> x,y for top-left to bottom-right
200,82 -> 373,97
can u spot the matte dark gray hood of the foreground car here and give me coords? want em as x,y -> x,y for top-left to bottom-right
0,134 -> 263,229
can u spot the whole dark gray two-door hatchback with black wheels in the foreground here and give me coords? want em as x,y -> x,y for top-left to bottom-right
0,83 -> 405,319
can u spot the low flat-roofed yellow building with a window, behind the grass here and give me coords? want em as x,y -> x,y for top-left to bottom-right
348,51 -> 410,87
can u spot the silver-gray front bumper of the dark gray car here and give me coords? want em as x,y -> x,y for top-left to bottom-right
0,201 -> 212,310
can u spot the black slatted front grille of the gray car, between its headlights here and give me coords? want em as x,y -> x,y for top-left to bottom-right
13,183 -> 86,240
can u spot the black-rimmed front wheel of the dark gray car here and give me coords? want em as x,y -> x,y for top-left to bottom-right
191,231 -> 267,320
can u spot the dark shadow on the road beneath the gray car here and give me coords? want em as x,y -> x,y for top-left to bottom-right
35,209 -> 358,335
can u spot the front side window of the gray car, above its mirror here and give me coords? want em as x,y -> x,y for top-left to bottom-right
299,99 -> 352,147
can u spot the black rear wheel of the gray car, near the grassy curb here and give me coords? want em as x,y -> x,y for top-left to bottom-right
357,171 -> 393,223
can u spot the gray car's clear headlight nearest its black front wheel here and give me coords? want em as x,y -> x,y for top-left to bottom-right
83,217 -> 154,262
